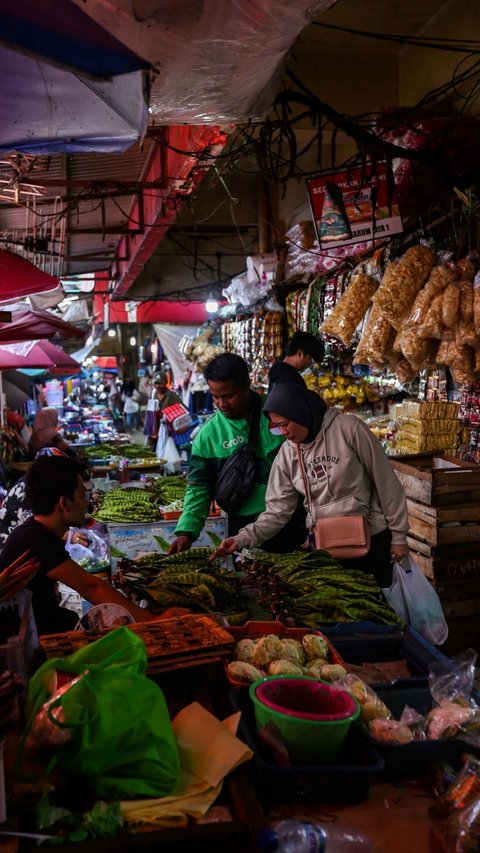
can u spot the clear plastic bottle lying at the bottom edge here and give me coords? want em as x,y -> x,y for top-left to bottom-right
257,820 -> 373,853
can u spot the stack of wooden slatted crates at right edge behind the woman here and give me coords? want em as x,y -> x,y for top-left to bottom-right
390,454 -> 480,654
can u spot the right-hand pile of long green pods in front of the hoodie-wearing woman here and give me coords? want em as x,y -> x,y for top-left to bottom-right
241,549 -> 401,628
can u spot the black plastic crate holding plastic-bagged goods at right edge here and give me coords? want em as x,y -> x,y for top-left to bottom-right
368,679 -> 480,777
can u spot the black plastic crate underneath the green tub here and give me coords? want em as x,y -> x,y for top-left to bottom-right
230,688 -> 384,803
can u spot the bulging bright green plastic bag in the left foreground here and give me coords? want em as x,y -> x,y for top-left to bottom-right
22,627 -> 180,799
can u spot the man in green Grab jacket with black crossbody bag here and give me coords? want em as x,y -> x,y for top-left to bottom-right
169,353 -> 306,554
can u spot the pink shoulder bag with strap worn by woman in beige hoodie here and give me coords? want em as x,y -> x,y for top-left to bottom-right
295,444 -> 373,560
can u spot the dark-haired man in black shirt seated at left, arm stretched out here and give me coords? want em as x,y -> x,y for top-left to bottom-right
0,456 -> 176,634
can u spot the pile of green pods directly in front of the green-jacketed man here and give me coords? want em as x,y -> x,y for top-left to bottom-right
114,548 -> 244,624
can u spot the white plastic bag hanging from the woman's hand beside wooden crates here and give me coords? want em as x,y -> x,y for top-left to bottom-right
382,555 -> 448,646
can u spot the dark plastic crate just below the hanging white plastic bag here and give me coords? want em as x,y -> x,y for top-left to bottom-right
319,622 -> 449,681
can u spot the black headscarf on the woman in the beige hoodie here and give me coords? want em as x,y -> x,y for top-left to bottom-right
263,382 -> 327,443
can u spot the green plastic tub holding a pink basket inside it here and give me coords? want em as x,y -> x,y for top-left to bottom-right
249,676 -> 360,764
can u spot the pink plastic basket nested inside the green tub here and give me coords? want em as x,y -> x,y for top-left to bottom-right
255,676 -> 356,721
